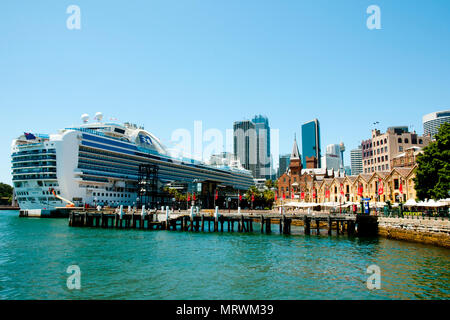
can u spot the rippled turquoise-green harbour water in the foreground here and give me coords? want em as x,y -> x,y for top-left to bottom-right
0,211 -> 450,300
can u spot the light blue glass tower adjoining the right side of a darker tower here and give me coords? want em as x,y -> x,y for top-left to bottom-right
252,115 -> 272,179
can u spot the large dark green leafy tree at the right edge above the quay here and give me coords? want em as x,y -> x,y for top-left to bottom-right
414,123 -> 450,200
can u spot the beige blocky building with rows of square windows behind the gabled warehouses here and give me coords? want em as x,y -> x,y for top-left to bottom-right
361,127 -> 431,174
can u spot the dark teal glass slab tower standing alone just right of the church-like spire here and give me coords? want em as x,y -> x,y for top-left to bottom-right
302,119 -> 321,168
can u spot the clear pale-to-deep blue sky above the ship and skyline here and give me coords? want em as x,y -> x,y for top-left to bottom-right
0,0 -> 450,183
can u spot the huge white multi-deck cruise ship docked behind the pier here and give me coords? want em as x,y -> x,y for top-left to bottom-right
12,113 -> 254,211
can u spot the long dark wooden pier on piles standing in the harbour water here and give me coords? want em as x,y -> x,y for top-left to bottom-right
69,209 -> 378,236
